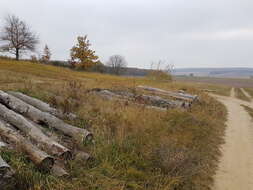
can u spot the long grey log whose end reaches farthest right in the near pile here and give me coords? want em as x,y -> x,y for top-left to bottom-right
0,90 -> 93,142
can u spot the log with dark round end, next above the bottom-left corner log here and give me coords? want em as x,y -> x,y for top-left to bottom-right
0,120 -> 54,171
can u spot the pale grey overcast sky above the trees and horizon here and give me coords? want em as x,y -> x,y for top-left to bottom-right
0,0 -> 253,68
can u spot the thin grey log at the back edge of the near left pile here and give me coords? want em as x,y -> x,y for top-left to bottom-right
8,91 -> 77,119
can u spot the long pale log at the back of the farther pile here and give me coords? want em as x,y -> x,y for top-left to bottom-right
137,86 -> 198,101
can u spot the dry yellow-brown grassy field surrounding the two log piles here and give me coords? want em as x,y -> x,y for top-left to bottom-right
0,60 -> 226,190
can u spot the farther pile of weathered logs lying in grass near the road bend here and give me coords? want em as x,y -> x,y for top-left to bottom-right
90,86 -> 199,111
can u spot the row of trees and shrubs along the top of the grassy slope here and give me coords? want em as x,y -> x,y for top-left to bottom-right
0,15 -> 171,78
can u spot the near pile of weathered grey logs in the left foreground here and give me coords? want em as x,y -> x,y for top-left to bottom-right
0,90 -> 93,186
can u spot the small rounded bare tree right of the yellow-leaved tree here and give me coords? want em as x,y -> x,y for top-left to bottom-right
106,55 -> 127,75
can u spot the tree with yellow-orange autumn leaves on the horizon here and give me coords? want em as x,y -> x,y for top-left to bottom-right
70,35 -> 100,70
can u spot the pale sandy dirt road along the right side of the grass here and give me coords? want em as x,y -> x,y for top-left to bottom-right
213,89 -> 253,190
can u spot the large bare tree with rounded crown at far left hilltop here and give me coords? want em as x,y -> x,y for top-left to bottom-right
0,15 -> 39,60
